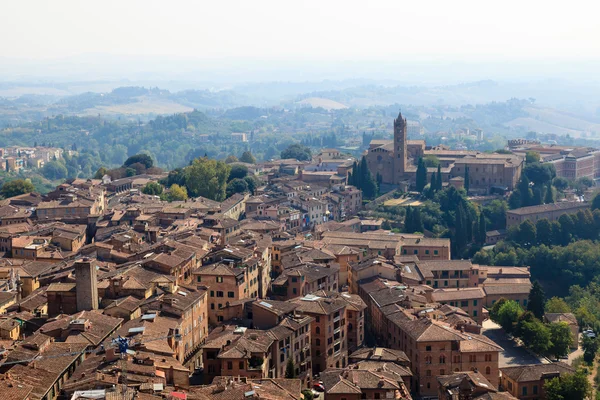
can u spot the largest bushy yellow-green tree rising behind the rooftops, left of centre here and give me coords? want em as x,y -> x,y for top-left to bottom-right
185,158 -> 231,201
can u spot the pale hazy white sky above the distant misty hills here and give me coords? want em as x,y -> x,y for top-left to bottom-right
0,0 -> 600,83
